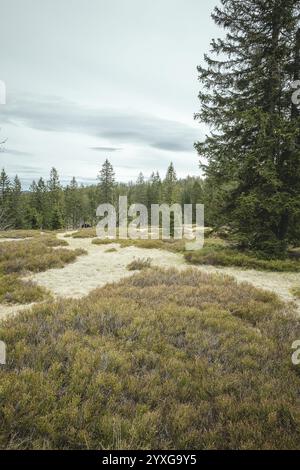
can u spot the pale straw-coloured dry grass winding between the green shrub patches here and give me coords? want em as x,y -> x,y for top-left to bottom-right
0,231 -> 300,318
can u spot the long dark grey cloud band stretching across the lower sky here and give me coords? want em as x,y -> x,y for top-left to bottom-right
2,97 -> 199,152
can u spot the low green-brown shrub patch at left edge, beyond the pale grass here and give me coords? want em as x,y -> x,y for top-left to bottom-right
0,231 -> 84,304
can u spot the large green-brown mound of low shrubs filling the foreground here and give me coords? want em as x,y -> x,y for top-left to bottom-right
0,269 -> 300,449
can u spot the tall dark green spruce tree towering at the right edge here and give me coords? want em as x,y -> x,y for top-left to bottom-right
196,0 -> 300,256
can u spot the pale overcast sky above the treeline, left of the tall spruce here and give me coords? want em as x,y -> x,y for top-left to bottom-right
0,0 -> 222,187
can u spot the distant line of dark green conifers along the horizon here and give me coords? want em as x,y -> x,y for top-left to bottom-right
0,160 -> 214,230
